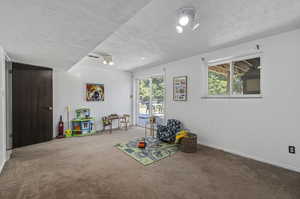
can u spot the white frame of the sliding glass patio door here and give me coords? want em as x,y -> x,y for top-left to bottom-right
134,74 -> 167,126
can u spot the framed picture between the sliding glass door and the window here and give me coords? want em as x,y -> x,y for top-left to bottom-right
173,76 -> 187,101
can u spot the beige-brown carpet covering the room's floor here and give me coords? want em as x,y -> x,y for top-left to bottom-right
0,128 -> 300,199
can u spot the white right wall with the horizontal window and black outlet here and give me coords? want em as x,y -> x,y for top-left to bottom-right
134,30 -> 300,172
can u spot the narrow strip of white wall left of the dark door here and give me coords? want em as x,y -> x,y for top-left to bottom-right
0,46 -> 6,172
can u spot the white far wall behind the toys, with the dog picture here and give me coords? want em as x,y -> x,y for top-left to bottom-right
53,64 -> 132,136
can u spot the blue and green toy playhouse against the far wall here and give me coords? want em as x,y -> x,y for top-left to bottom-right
72,108 -> 96,136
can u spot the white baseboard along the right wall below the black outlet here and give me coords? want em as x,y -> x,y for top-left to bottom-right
198,142 -> 300,173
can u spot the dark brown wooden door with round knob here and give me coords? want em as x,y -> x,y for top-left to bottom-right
12,63 -> 53,148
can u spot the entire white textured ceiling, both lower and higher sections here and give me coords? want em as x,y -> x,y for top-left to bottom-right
0,0 -> 300,70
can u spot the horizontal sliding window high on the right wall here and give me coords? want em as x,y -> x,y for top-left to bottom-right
207,57 -> 261,97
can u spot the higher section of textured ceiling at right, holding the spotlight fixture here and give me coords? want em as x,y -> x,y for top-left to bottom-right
86,0 -> 300,70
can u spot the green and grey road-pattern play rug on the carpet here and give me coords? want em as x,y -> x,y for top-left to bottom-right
115,137 -> 178,166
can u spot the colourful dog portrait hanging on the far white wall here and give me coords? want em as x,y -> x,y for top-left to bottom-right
86,84 -> 104,102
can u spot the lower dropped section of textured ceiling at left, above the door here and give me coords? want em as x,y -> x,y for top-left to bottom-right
0,0 -> 150,69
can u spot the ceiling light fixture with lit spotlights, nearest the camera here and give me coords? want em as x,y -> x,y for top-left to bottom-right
176,8 -> 200,33
